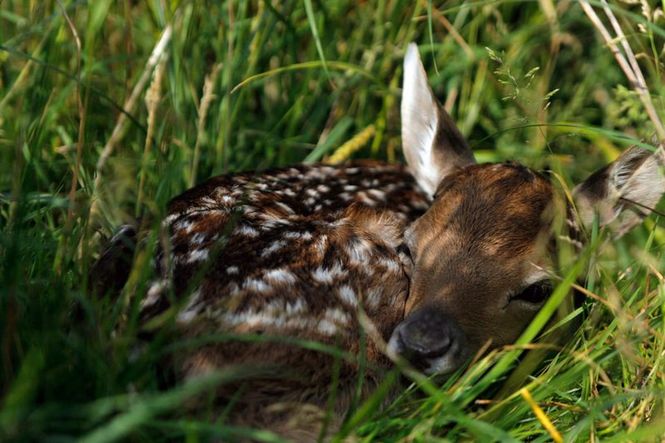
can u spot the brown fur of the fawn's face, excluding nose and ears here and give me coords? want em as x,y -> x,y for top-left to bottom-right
407,164 -> 553,352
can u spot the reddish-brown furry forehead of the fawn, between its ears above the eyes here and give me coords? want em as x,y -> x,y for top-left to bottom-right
415,164 -> 554,257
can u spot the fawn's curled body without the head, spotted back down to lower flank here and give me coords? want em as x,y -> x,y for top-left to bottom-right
142,162 -> 429,379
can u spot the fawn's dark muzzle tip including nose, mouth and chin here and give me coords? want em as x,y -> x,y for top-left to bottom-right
386,308 -> 467,375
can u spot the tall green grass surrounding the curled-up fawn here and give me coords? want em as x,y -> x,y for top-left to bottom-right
0,0 -> 665,442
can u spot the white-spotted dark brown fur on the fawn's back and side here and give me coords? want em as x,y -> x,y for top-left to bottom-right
142,162 -> 429,326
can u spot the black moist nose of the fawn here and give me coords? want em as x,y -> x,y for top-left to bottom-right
398,308 -> 462,368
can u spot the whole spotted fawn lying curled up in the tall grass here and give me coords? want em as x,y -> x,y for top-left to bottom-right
94,44 -> 665,440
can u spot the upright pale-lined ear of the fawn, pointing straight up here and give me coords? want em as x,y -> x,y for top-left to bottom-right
401,43 -> 475,196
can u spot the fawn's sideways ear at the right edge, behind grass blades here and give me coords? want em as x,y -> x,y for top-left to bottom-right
573,147 -> 665,236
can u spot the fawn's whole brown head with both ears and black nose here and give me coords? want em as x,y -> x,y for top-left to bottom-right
388,44 -> 665,373
